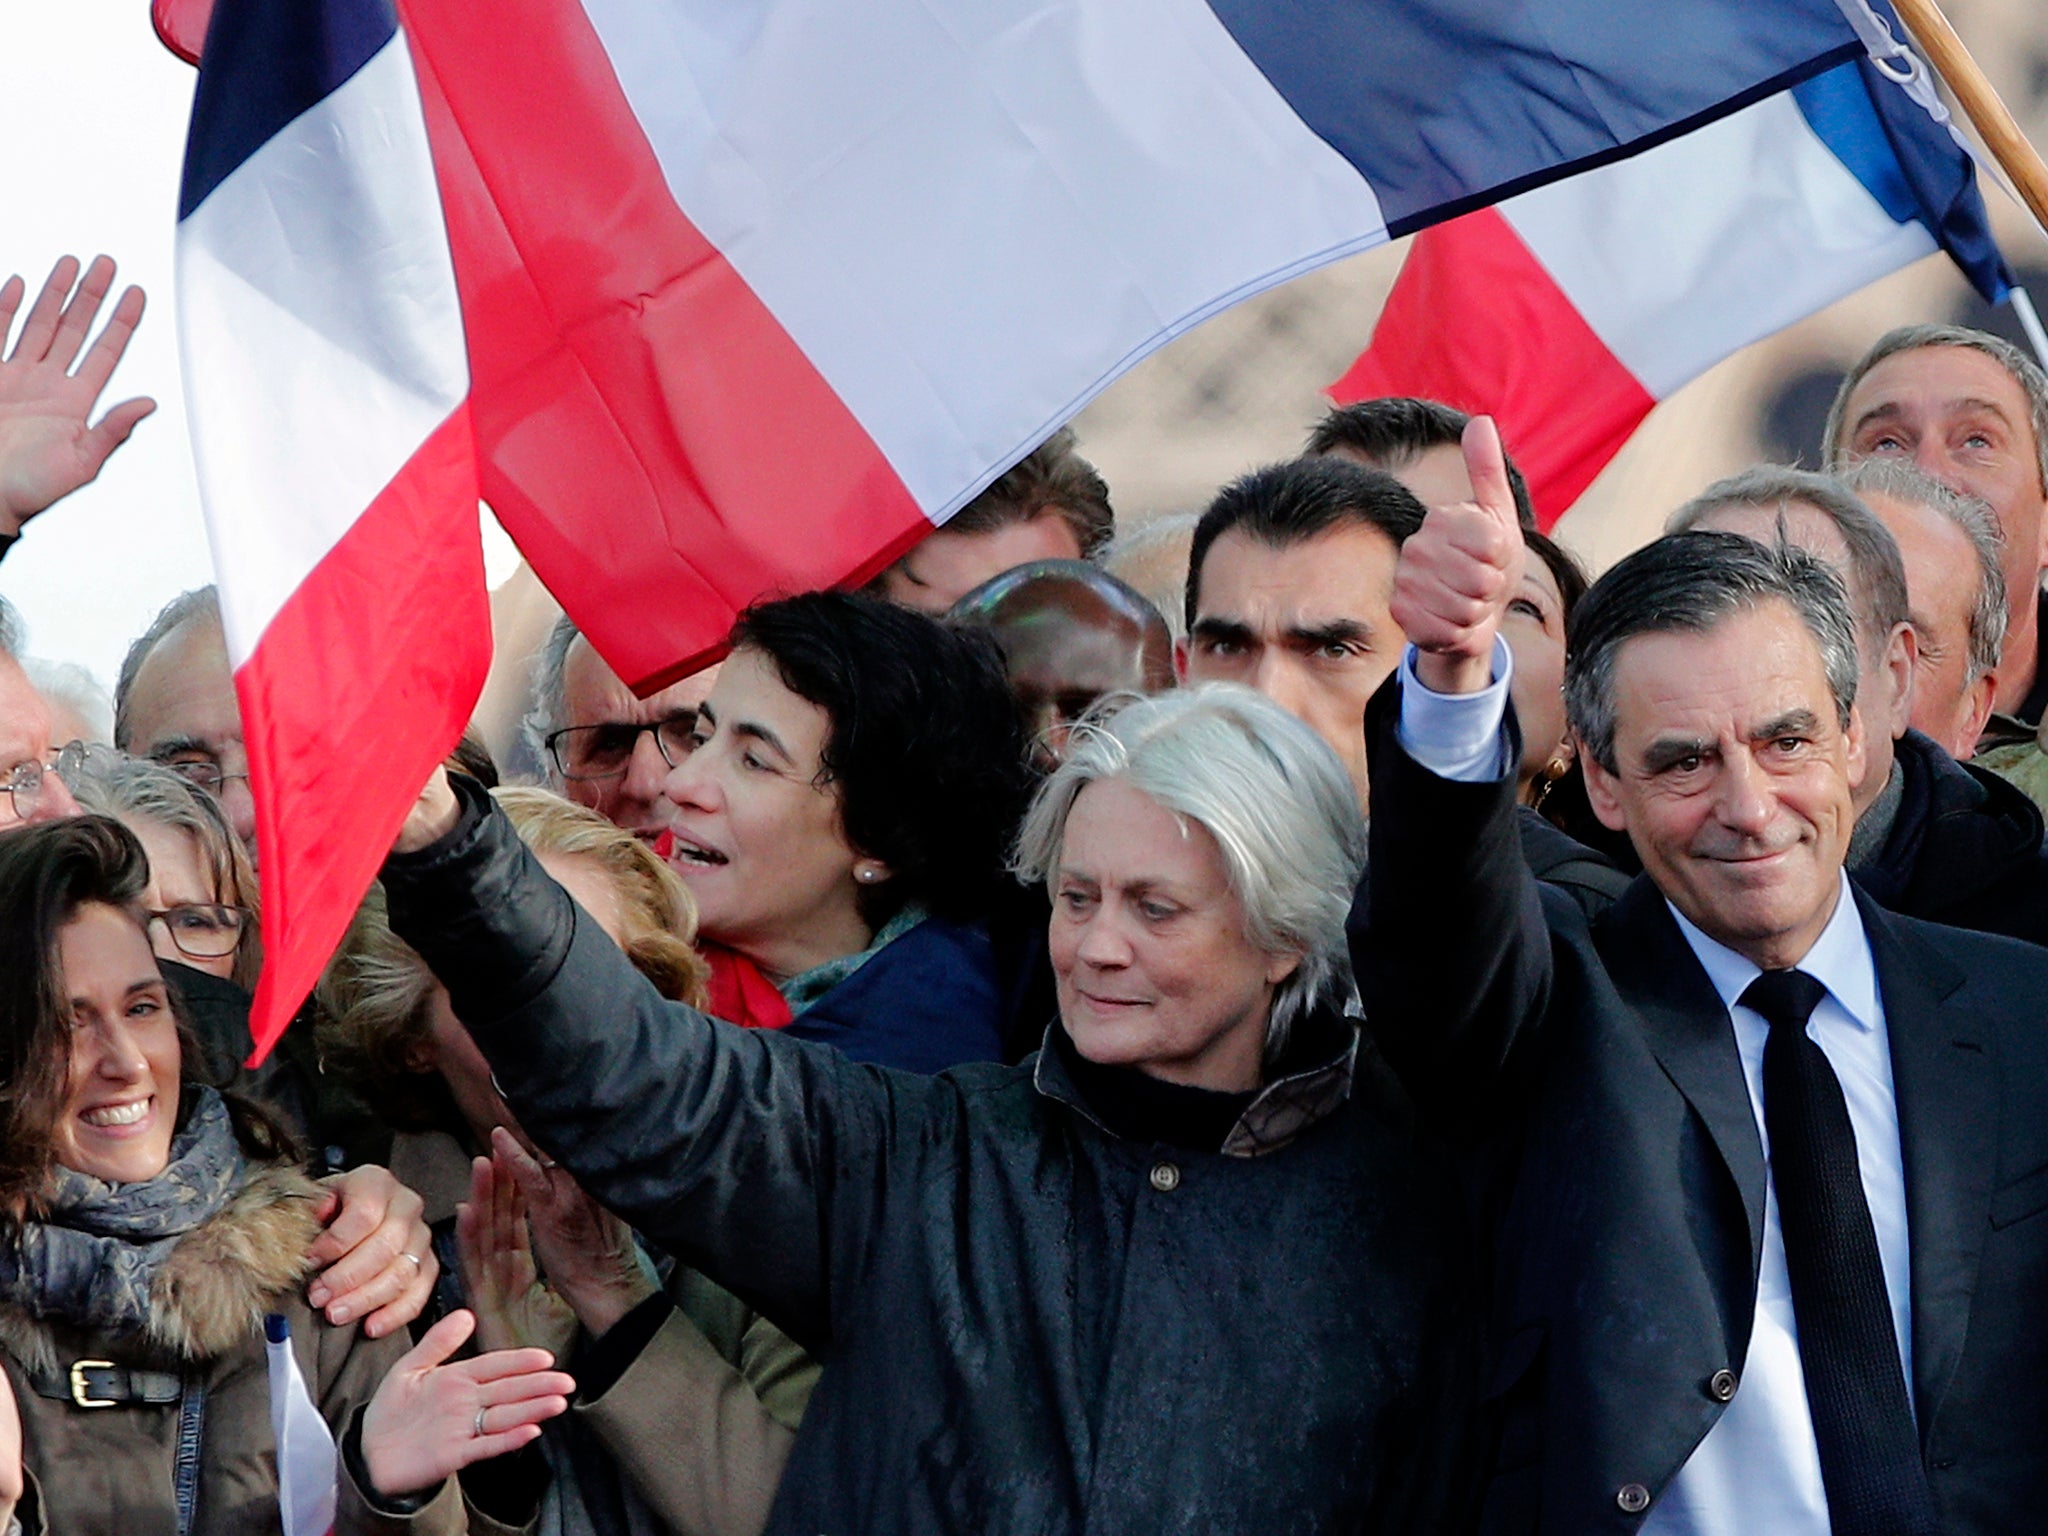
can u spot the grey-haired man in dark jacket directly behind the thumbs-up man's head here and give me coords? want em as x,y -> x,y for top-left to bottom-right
1669,465 -> 2048,944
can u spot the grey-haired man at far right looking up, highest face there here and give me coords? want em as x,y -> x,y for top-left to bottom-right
1823,326 -> 2048,739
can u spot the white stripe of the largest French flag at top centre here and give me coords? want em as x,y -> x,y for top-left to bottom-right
584,0 -> 1386,518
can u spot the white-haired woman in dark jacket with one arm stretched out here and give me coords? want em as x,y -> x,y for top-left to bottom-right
385,686 -> 1470,1536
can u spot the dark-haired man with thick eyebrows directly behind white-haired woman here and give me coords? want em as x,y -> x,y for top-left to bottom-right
1174,459 -> 1423,805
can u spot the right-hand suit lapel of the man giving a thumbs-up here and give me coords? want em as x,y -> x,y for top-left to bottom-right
1858,893 -> 1999,1436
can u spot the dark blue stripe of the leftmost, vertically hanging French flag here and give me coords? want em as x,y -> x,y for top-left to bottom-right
178,0 -> 397,219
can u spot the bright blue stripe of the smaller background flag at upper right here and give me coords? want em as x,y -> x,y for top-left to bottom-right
1792,59 -> 2013,303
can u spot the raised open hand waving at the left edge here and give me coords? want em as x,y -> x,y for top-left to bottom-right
0,256 -> 156,541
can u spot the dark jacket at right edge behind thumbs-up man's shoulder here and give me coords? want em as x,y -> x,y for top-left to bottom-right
1853,731 -> 2048,944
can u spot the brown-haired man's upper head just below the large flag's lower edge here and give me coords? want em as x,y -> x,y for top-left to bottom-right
866,426 -> 1116,618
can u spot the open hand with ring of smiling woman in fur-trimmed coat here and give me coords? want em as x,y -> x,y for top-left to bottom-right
362,1311 -> 575,1497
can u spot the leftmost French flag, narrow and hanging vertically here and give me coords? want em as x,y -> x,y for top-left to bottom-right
178,0 -> 489,1053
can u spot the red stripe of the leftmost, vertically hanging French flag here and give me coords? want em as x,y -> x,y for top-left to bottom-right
236,410 -> 492,1051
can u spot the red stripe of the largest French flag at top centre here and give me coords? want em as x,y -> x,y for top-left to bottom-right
401,0 -> 932,688
